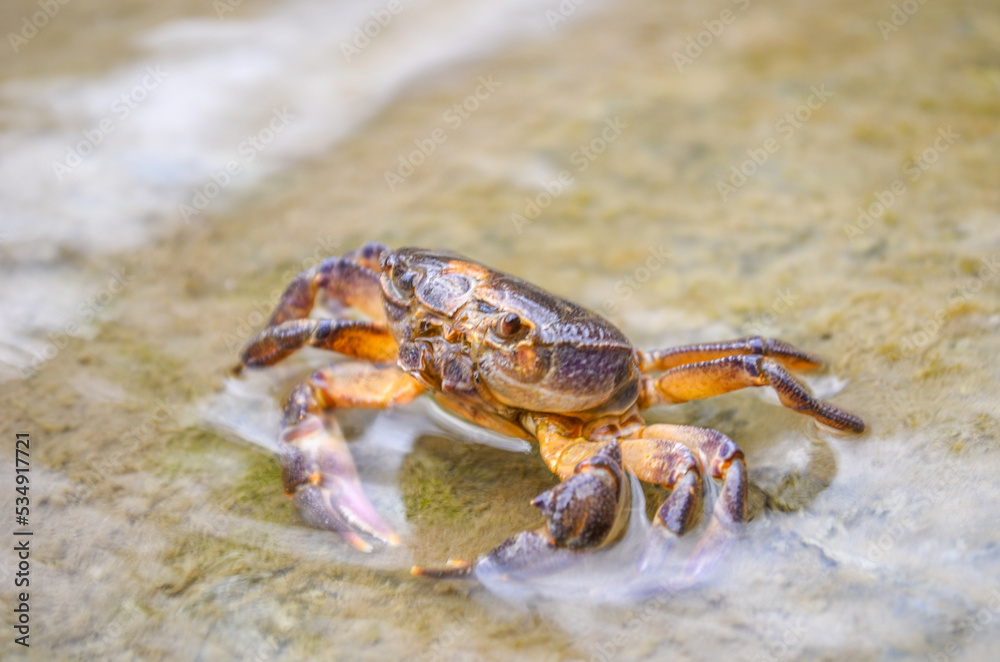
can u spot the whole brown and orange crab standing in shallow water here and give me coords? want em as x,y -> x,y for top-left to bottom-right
232,242 -> 865,577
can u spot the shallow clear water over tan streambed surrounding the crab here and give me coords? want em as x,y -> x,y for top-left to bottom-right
0,1 -> 1000,660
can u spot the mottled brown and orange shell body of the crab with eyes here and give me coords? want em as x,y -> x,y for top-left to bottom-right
381,248 -> 639,420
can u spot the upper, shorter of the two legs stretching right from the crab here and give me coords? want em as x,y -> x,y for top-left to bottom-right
636,336 -> 823,372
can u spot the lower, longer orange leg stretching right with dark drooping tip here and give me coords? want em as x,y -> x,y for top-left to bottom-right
639,356 -> 865,434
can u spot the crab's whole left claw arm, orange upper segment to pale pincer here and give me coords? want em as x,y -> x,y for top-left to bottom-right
278,364 -> 423,552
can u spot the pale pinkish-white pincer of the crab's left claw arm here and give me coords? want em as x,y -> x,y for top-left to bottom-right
278,414 -> 399,552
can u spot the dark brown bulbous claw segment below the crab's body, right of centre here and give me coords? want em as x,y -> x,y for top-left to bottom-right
531,441 -> 626,548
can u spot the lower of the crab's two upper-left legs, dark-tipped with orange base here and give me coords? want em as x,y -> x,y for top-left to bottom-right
240,319 -> 399,368
